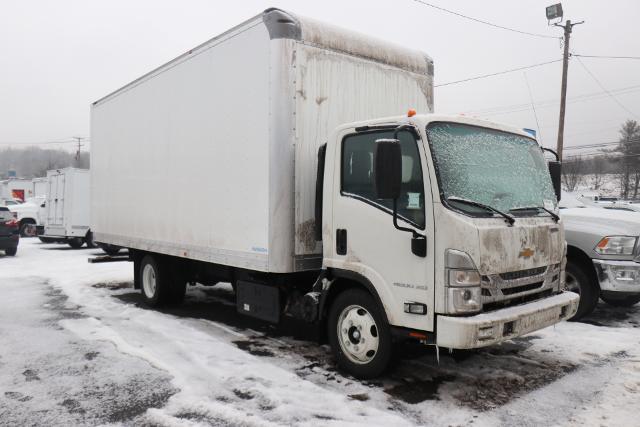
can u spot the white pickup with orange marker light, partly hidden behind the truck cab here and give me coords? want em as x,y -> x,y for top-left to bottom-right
560,195 -> 640,319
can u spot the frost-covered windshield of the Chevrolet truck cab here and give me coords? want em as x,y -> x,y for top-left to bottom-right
427,122 -> 557,215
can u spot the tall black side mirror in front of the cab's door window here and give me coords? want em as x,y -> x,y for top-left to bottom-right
373,139 -> 402,200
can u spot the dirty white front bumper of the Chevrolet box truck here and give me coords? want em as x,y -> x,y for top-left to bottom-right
436,292 -> 580,349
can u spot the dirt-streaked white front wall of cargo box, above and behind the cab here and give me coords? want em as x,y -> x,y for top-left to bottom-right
295,43 -> 433,257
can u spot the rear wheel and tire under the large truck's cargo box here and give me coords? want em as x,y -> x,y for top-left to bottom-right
138,255 -> 187,307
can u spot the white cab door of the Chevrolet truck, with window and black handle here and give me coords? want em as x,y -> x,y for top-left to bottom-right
331,130 -> 434,331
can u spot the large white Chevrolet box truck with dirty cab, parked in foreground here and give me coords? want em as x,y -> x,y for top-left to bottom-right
91,9 -> 578,378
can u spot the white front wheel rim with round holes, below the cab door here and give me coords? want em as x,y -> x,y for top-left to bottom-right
337,305 -> 380,365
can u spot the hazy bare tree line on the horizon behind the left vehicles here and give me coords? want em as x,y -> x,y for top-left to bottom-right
0,147 -> 89,179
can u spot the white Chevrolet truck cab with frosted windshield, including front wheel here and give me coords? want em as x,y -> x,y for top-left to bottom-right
317,113 -> 579,376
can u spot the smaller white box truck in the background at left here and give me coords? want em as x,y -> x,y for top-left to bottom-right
41,167 -> 94,249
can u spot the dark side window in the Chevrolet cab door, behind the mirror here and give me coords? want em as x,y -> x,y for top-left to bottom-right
341,131 -> 425,229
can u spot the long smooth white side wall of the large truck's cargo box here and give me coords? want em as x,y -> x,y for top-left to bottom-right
91,19 -> 277,270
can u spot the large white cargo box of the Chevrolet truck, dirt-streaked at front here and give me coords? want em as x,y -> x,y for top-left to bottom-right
91,10 -> 433,273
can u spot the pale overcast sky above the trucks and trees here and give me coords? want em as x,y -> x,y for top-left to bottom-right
0,0 -> 640,154
